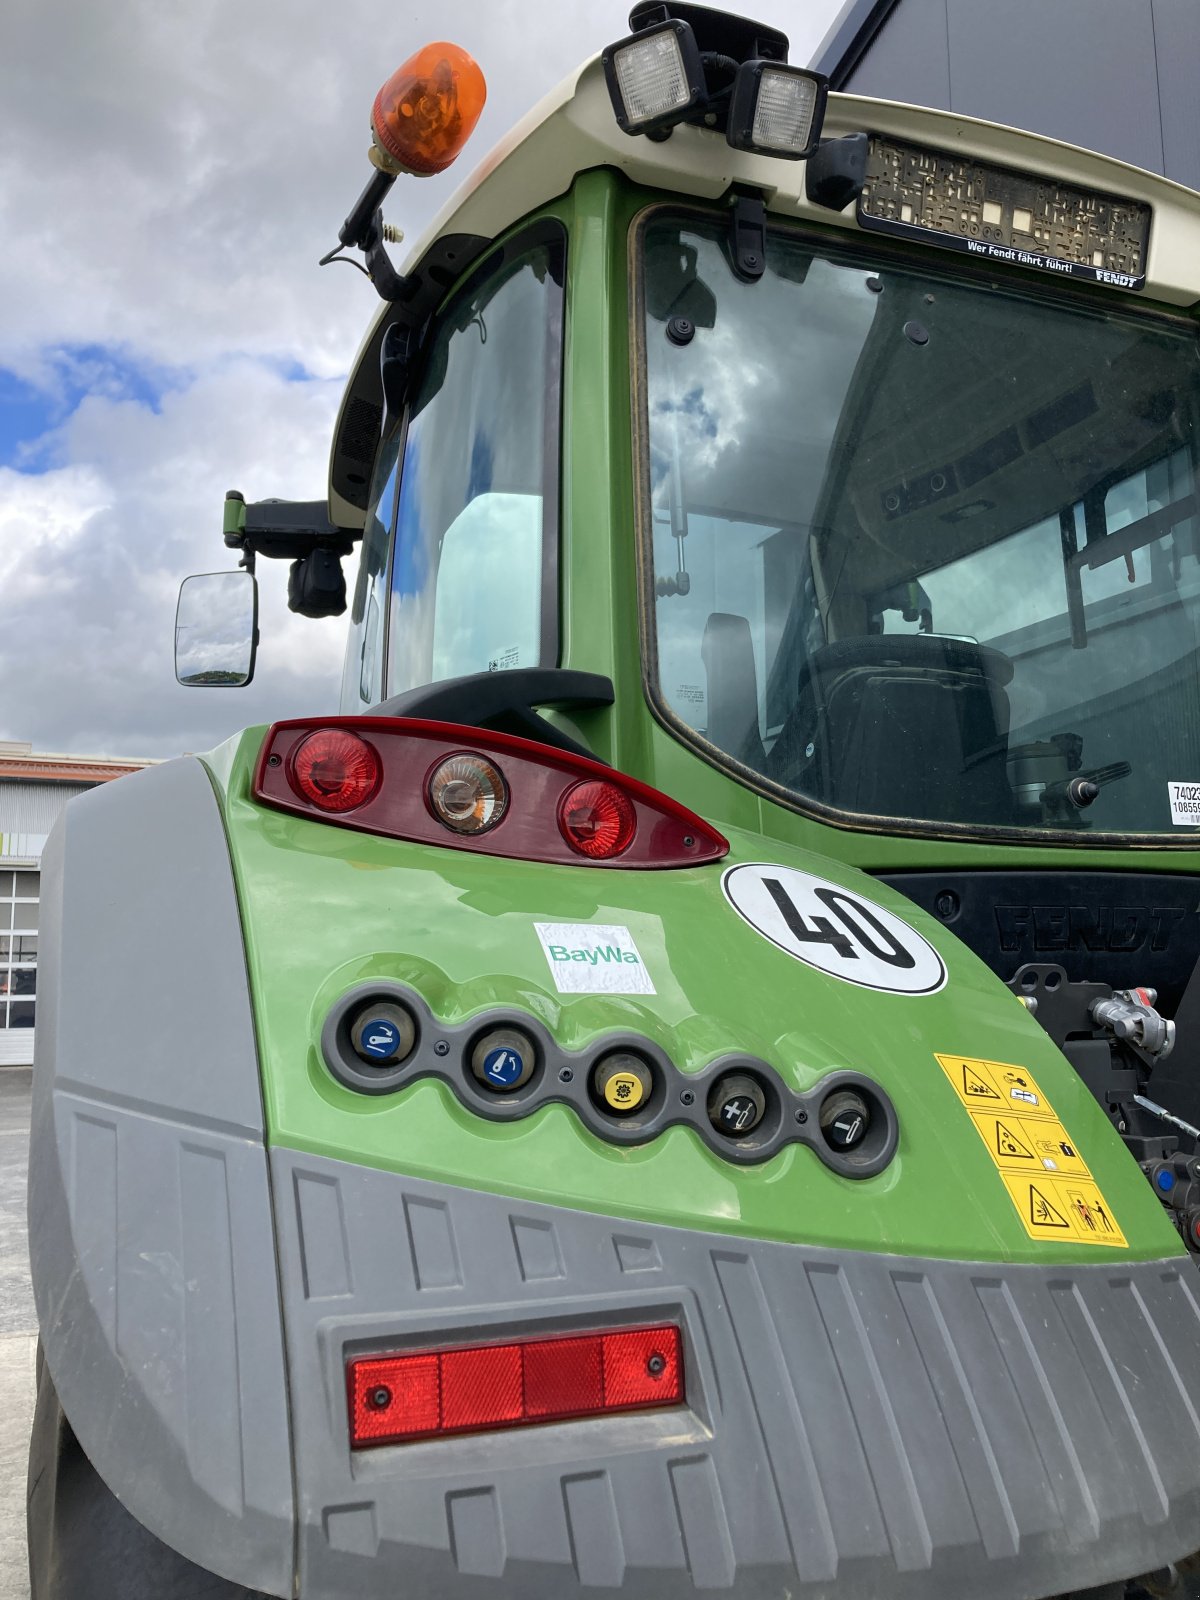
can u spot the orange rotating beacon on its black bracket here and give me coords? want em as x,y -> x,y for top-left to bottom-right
320,42 -> 488,301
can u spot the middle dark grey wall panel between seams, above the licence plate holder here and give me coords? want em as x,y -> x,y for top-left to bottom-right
947,0 -> 1163,173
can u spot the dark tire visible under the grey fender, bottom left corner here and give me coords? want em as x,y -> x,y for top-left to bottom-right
27,1344 -> 270,1600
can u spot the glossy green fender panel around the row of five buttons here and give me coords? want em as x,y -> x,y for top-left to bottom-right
208,730 -> 1181,1264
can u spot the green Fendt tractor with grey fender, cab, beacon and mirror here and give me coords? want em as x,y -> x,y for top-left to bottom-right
29,0 -> 1200,1600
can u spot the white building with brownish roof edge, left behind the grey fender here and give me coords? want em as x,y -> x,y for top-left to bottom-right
0,741 -> 149,1067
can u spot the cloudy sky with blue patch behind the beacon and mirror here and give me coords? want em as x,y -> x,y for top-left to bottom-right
0,0 -> 840,755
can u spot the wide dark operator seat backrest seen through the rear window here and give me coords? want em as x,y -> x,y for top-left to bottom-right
768,634 -> 1014,826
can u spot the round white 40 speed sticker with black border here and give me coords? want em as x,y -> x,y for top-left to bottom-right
722,861 -> 946,995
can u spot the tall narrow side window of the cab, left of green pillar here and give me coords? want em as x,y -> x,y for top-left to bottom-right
387,227 -> 563,694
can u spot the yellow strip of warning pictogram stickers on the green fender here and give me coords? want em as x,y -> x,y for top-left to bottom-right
938,1054 -> 1126,1246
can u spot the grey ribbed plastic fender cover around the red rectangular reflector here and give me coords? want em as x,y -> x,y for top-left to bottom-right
30,762 -> 1200,1600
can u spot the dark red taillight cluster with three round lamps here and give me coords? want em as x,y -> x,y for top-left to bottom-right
254,717 -> 730,867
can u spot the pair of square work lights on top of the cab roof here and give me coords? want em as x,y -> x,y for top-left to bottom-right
600,0 -> 829,160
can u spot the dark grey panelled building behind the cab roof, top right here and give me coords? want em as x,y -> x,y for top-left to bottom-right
813,0 -> 1200,189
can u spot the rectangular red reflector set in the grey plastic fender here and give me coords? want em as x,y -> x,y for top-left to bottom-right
346,1328 -> 683,1450
